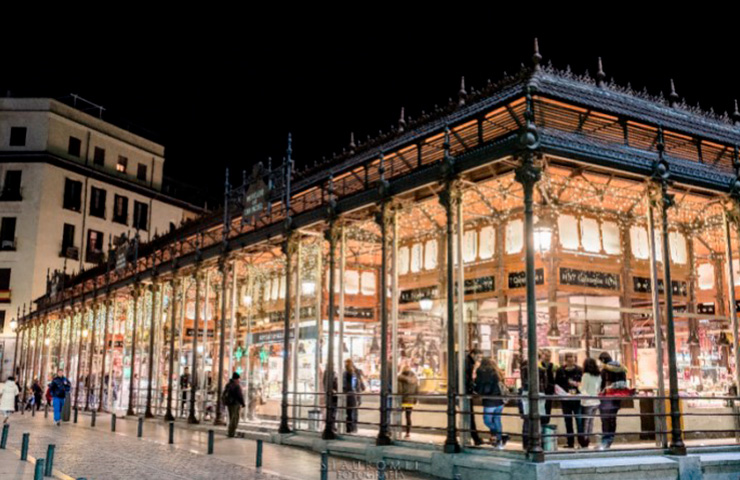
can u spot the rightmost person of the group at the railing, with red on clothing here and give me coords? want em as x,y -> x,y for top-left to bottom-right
599,352 -> 629,450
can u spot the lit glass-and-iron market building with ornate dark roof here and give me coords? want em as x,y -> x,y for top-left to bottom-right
17,44 -> 740,472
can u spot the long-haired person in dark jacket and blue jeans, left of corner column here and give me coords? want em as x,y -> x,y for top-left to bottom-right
474,357 -> 508,450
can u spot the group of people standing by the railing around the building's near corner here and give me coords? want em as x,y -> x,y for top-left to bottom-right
465,349 -> 630,449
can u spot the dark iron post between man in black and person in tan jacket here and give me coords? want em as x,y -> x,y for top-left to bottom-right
376,199 -> 391,445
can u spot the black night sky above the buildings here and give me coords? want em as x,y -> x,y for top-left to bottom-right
0,19 -> 740,208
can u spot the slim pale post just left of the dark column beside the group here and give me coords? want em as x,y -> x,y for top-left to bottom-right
647,201 -> 668,448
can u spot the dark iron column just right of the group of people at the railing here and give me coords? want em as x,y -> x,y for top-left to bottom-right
654,128 -> 686,455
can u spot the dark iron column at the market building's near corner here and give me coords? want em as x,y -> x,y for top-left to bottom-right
515,88 -> 545,462
